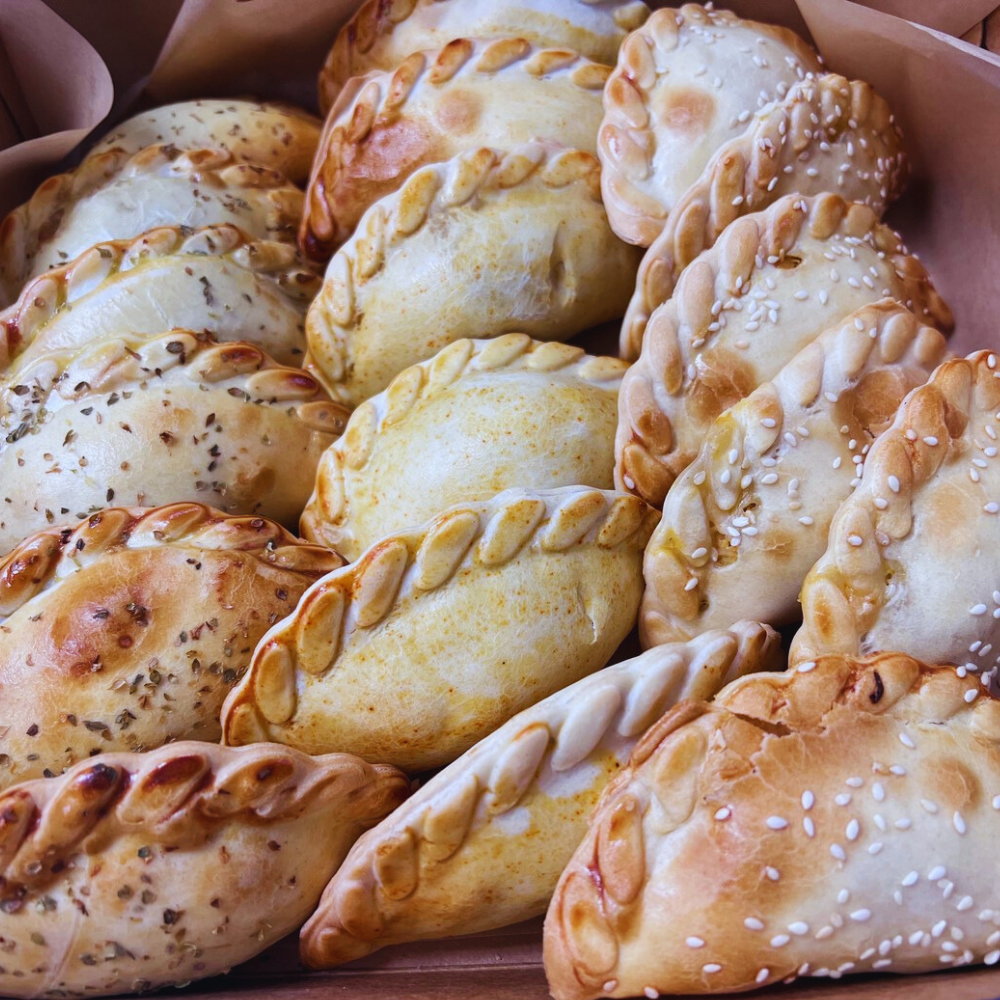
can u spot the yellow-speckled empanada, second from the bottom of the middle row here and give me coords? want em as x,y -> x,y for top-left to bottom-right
222,486 -> 659,771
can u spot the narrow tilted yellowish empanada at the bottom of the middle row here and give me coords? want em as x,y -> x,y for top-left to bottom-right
302,622 -> 780,968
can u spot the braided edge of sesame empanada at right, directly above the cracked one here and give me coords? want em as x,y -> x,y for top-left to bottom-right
790,351 -> 1000,663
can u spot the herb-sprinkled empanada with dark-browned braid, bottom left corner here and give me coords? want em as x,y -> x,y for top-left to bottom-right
0,743 -> 407,998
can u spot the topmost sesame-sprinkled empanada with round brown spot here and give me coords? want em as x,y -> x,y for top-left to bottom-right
598,3 -> 821,246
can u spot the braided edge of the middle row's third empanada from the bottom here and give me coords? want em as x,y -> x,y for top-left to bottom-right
302,333 -> 628,549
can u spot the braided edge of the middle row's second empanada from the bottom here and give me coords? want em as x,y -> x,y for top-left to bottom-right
229,486 -> 660,742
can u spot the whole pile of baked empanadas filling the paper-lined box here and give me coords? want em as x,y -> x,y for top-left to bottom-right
0,0 -> 1000,1000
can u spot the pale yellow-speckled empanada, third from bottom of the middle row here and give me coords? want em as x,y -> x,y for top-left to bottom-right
302,333 -> 627,559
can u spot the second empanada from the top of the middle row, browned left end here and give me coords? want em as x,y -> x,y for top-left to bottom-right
299,38 -> 611,258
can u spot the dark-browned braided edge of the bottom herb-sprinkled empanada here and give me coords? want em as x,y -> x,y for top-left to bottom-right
0,741 -> 409,891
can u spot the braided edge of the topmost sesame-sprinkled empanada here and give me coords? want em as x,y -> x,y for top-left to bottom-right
597,3 -> 820,246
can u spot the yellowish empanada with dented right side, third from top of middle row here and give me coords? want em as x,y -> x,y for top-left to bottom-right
306,142 -> 639,406
